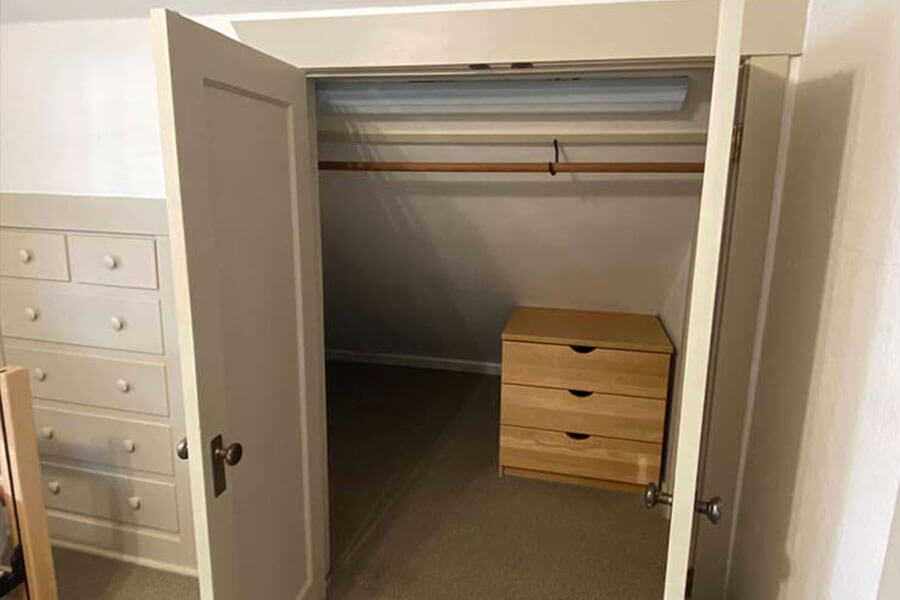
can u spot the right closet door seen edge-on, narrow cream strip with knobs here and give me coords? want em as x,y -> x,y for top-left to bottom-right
664,0 -> 744,600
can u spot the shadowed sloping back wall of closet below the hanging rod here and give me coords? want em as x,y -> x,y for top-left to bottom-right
320,173 -> 699,362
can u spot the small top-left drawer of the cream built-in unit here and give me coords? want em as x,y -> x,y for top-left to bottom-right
0,229 -> 69,281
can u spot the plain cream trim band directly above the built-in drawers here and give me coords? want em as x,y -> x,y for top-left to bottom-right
0,192 -> 168,235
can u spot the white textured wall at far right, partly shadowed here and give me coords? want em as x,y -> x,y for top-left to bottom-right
730,0 -> 900,600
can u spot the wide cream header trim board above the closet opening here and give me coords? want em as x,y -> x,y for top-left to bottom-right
231,0 -> 807,74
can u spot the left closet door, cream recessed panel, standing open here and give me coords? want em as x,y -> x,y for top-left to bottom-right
151,10 -> 327,600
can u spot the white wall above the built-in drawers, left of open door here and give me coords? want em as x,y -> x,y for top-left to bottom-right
0,20 -> 164,196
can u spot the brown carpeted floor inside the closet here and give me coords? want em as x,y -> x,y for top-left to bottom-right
328,363 -> 668,600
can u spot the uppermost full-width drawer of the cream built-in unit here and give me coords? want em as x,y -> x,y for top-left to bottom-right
0,284 -> 163,353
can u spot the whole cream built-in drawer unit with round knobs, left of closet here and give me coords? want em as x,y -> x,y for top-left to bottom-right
0,192 -> 196,573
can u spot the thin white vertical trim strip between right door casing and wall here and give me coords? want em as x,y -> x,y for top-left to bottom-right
725,54 -> 800,592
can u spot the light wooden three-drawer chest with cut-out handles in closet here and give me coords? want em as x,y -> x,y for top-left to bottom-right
500,307 -> 673,491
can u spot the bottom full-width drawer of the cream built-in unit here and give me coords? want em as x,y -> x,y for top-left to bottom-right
42,465 -> 178,531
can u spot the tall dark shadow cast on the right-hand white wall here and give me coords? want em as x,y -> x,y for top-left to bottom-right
729,68 -> 877,600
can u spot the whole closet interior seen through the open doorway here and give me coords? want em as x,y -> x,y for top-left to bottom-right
316,64 -> 711,598
